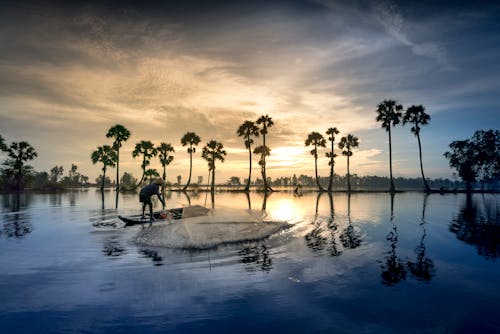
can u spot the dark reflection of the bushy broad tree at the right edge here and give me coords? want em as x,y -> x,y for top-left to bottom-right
449,194 -> 500,259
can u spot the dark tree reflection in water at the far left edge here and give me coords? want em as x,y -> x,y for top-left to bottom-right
0,193 -> 33,238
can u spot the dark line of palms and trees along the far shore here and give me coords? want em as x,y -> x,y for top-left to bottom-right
0,100 -> 500,192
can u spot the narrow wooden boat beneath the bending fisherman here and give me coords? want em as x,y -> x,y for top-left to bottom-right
118,205 -> 209,226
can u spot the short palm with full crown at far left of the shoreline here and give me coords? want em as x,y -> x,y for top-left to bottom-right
4,141 -> 38,190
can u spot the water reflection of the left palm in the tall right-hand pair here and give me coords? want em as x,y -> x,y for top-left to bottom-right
381,193 -> 406,286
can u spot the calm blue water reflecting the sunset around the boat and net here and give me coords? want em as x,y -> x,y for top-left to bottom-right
0,189 -> 500,333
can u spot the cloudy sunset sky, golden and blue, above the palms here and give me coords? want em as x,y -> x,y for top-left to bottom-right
0,0 -> 500,183
